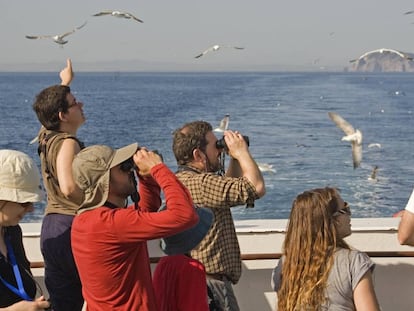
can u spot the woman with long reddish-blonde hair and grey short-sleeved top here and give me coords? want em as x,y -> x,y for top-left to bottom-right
272,187 -> 380,311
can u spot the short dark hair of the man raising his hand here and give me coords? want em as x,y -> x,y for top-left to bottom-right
33,85 -> 70,131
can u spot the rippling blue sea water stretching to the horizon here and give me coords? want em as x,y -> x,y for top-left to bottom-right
0,72 -> 414,222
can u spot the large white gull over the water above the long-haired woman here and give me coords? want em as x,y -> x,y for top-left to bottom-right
328,112 -> 362,169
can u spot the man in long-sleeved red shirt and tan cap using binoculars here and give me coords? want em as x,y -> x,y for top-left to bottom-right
71,144 -> 198,311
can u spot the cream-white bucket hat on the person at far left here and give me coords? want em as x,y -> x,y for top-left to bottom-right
0,149 -> 44,203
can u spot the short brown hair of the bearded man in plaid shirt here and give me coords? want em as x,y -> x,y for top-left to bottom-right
172,121 -> 213,165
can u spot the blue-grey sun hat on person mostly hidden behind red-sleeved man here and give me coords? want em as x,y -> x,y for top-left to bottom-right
159,206 -> 214,255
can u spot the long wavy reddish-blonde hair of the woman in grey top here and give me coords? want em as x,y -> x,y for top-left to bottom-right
277,187 -> 349,311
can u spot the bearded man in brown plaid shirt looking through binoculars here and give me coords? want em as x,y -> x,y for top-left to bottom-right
173,121 -> 266,311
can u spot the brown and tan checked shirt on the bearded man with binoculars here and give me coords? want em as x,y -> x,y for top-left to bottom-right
176,168 -> 259,284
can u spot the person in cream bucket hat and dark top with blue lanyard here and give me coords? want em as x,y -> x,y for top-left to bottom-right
0,149 -> 50,311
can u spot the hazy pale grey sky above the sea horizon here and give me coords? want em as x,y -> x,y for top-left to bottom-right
0,0 -> 414,71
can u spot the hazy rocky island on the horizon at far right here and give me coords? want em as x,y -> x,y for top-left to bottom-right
346,48 -> 414,72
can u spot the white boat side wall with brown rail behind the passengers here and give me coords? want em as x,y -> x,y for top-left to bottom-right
22,218 -> 414,311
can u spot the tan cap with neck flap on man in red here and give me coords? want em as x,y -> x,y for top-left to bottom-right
72,143 -> 138,213
